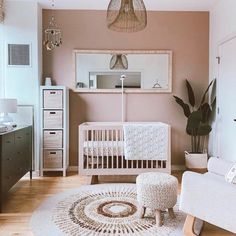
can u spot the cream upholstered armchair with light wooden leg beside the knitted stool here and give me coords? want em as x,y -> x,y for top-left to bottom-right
180,158 -> 236,236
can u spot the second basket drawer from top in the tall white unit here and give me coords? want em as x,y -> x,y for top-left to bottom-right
43,111 -> 63,129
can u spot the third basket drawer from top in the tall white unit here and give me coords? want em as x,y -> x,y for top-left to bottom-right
43,130 -> 63,148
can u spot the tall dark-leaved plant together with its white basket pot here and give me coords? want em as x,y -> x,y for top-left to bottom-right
174,80 -> 216,171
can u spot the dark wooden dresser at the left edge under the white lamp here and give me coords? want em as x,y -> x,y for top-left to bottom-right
0,126 -> 32,212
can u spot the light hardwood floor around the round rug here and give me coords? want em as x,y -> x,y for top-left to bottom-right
0,172 -> 234,236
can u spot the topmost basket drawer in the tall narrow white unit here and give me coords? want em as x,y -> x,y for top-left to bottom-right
43,90 -> 63,109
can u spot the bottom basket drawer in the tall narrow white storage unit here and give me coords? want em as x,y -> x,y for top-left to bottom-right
43,150 -> 63,169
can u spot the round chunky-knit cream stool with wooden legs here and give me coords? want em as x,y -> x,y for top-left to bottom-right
136,172 -> 178,226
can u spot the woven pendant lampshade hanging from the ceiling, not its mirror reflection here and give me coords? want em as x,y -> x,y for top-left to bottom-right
107,0 -> 147,32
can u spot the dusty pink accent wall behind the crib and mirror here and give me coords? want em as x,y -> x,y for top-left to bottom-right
43,10 -> 209,165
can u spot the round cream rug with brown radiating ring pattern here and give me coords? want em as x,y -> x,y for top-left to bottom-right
31,184 -> 186,236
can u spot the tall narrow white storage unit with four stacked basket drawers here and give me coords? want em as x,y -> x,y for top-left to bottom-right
40,86 -> 69,176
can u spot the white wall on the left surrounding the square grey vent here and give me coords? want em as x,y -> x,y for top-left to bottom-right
2,0 -> 42,172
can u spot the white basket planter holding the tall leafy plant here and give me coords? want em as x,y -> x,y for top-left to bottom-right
184,151 -> 208,169
